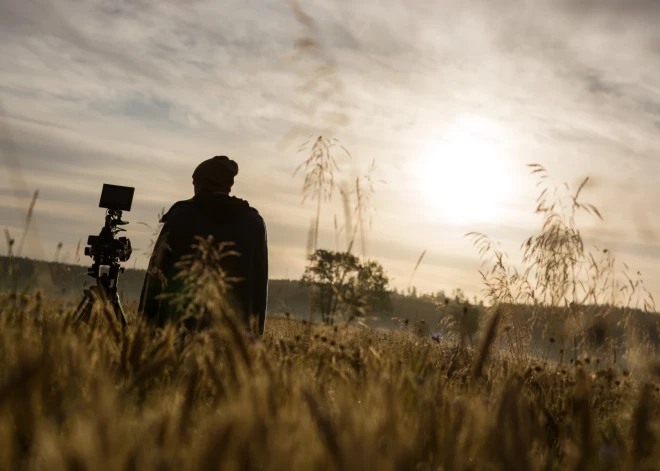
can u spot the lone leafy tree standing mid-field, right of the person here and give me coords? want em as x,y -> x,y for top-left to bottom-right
300,249 -> 392,324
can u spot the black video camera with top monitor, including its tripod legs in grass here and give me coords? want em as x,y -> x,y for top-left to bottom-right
75,184 -> 135,326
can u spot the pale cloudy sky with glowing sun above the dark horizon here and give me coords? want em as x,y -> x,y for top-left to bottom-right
0,0 -> 660,299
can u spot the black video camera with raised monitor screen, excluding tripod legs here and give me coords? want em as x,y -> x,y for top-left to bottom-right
85,184 -> 135,280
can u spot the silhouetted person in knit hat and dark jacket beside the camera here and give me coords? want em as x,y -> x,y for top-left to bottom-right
139,156 -> 268,334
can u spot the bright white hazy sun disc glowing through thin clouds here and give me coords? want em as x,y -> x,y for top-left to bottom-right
413,116 -> 514,225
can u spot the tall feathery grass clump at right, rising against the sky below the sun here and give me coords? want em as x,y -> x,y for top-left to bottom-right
467,164 -> 657,361
